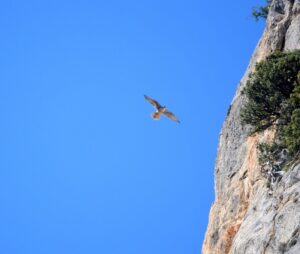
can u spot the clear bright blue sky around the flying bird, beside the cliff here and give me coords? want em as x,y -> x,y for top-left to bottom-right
0,0 -> 264,254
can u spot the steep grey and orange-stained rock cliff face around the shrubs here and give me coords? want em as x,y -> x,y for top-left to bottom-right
202,0 -> 300,254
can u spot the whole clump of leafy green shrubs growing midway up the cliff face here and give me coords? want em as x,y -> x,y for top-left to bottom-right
241,50 -> 300,169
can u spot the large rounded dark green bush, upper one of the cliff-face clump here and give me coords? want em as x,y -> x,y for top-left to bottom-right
241,50 -> 300,132
